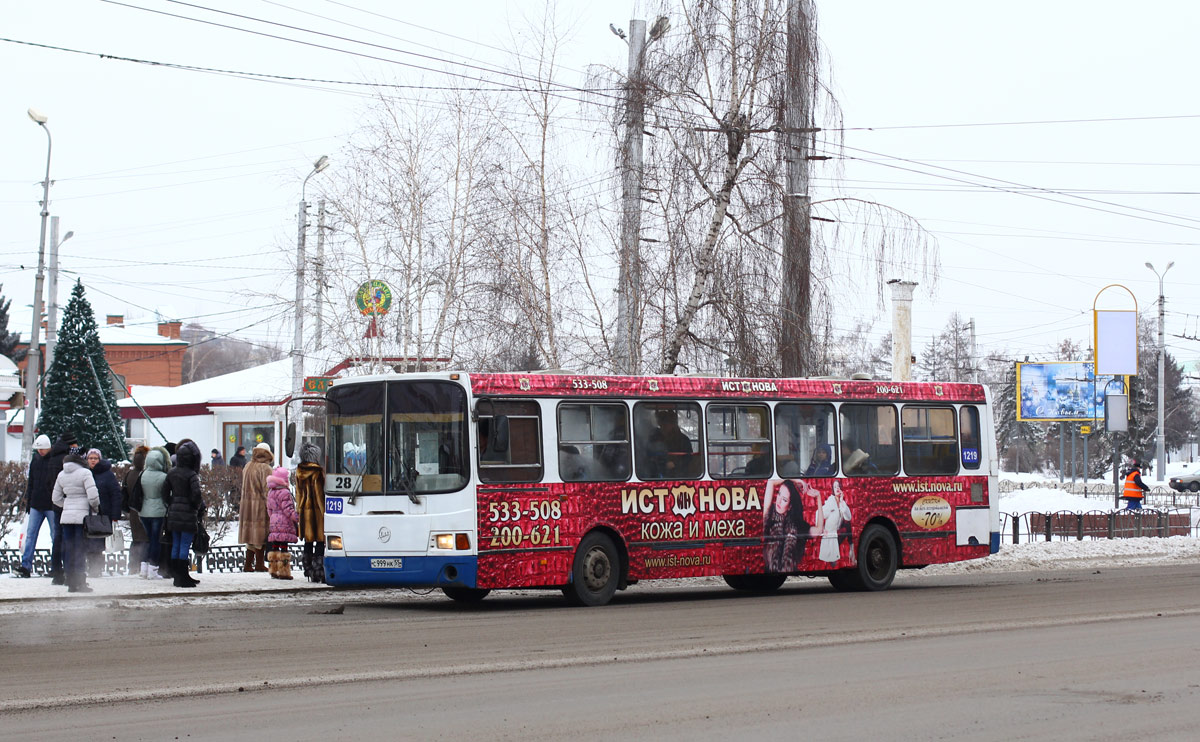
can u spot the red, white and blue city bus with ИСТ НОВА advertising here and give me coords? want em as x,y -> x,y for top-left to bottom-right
325,371 -> 1000,605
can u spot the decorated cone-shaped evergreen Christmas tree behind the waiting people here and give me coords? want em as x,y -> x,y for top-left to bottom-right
37,282 -> 127,461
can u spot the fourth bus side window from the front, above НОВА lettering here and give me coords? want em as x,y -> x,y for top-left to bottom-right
704,405 -> 774,479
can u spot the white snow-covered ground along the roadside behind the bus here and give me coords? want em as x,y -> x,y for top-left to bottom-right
0,472 -> 1200,614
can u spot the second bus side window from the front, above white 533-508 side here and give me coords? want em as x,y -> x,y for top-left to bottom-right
558,402 -> 632,481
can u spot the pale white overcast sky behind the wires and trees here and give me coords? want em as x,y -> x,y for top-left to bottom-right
0,0 -> 1200,374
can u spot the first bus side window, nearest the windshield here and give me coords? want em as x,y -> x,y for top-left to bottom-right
478,400 -> 542,483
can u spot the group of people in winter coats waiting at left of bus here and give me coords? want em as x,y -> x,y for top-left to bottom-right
16,432 -> 325,592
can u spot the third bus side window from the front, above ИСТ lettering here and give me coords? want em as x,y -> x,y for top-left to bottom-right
634,402 -> 704,480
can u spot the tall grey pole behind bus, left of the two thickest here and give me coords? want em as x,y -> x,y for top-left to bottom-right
614,20 -> 646,373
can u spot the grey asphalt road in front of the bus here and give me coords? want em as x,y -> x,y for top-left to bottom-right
0,564 -> 1200,742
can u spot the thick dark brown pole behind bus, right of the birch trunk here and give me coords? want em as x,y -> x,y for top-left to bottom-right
779,0 -> 816,376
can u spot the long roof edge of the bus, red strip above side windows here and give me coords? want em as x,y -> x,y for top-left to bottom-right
335,371 -> 986,403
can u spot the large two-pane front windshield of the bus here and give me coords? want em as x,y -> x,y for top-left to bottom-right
325,382 -> 468,495
